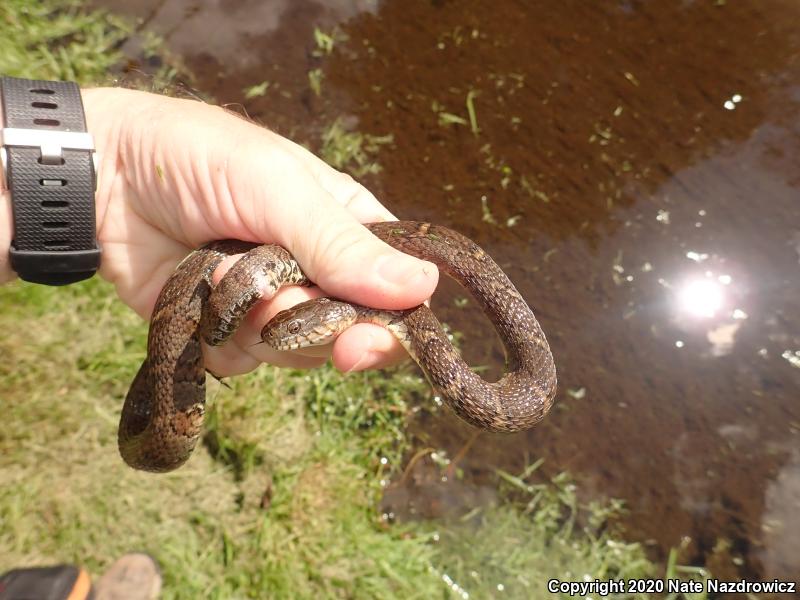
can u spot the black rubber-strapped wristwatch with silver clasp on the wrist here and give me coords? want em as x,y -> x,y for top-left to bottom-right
0,77 -> 100,285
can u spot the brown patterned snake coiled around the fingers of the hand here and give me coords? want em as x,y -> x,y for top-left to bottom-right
118,221 -> 557,472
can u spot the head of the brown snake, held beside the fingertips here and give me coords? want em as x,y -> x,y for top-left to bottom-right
261,298 -> 356,350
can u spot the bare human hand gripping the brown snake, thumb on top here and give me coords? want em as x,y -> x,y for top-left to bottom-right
0,88 -> 438,376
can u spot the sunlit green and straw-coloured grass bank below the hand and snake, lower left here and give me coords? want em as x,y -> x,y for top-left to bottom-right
0,281 -> 438,598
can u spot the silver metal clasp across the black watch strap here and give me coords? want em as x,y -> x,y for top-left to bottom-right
0,127 -> 98,190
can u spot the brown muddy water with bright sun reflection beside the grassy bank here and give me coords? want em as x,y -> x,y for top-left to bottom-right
95,0 -> 800,578
